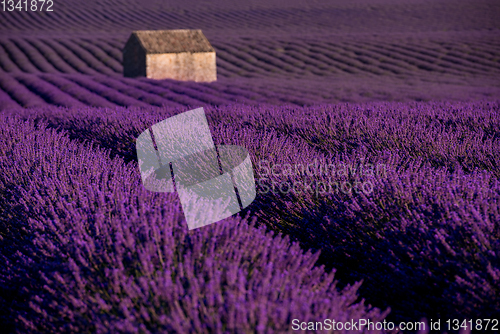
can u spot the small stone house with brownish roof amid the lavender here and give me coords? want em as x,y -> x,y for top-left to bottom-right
123,29 -> 217,82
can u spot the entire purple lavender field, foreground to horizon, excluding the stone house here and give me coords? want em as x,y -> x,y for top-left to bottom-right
0,0 -> 500,333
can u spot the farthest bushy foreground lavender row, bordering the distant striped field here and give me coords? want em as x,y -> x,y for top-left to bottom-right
9,101 -> 500,177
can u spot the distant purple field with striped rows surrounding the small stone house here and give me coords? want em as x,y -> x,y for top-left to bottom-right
0,1 -> 500,109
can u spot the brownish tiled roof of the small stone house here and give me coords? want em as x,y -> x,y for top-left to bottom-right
132,29 -> 215,53
